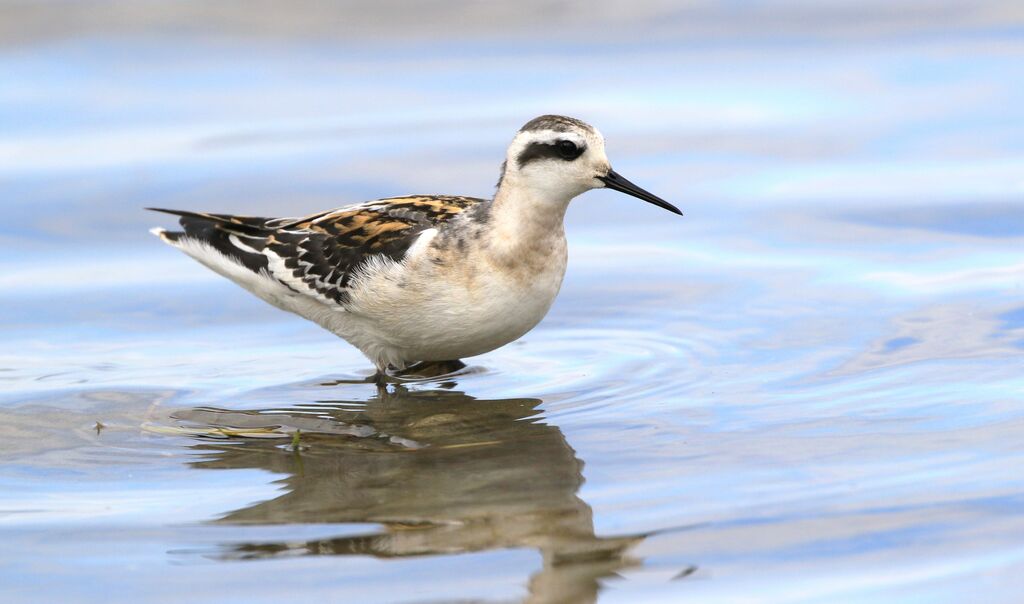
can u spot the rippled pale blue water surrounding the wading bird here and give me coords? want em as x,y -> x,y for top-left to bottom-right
0,2 -> 1024,602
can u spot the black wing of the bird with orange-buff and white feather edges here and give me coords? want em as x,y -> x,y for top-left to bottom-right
151,196 -> 483,305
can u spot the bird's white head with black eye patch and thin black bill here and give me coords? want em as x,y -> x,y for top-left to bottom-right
498,116 -> 682,214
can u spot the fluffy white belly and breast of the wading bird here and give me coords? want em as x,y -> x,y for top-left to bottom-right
322,230 -> 566,366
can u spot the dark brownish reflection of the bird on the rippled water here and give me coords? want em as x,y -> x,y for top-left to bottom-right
177,388 -> 643,602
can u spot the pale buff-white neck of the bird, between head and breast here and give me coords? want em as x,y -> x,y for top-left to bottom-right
488,180 -> 573,261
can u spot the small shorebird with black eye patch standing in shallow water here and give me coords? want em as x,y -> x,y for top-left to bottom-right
146,115 -> 682,383
